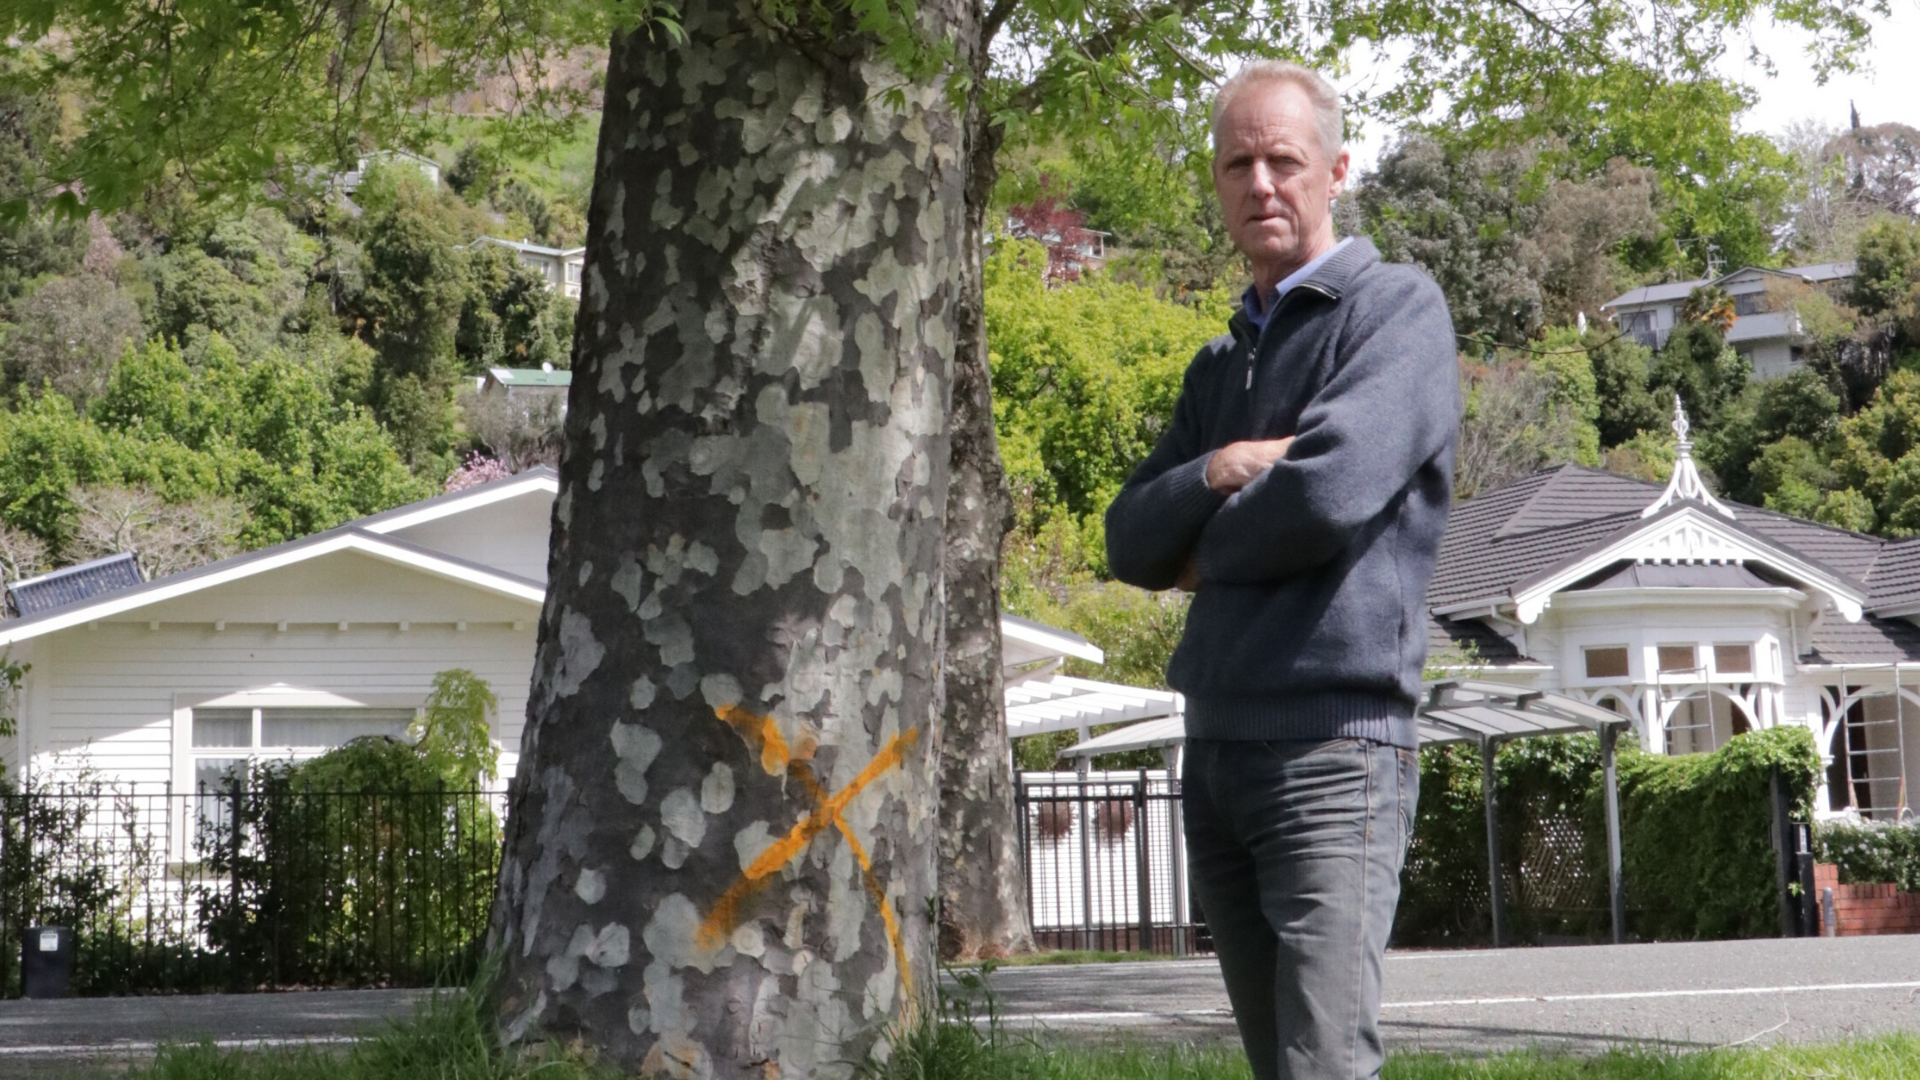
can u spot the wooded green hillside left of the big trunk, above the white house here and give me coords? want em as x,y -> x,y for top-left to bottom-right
0,71 -> 586,580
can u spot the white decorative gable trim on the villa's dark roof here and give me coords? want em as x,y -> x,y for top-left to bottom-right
1513,503 -> 1866,623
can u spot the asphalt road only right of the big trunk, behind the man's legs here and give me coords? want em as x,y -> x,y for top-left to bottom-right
993,936 -> 1920,1053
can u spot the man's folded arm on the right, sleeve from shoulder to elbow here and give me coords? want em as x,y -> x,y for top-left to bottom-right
1196,275 -> 1459,584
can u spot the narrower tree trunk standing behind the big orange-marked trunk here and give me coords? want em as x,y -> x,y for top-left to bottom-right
941,106 -> 1033,959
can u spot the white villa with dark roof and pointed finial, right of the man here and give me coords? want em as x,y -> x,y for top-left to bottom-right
1428,401 -> 1920,819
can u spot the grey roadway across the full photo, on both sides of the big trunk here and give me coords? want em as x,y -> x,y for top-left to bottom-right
0,936 -> 1920,1076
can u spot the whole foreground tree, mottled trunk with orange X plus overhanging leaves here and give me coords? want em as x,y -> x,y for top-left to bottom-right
0,0 -> 1889,1076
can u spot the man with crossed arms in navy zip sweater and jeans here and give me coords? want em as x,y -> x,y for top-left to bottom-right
1106,61 -> 1459,1080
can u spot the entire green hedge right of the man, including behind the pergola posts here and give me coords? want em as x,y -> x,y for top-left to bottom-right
1394,728 -> 1820,944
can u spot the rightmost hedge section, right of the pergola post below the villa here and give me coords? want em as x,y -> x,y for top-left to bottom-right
1619,728 -> 1820,940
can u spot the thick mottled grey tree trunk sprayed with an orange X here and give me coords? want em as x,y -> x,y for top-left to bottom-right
492,0 -> 977,1078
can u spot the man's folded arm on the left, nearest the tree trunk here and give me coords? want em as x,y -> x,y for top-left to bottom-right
1106,361 -> 1225,590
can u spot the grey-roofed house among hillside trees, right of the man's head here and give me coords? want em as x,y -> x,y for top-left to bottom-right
1601,263 -> 1853,380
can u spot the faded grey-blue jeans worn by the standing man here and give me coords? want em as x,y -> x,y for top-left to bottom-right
1181,738 -> 1419,1080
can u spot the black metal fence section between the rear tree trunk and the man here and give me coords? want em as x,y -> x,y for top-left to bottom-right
1014,769 -> 1212,955
